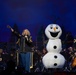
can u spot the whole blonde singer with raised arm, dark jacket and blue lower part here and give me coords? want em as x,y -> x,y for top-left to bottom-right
7,25 -> 34,72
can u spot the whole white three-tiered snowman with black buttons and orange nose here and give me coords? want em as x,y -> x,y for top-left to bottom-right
42,24 -> 65,69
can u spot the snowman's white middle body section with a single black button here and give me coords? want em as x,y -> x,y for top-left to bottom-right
46,39 -> 62,53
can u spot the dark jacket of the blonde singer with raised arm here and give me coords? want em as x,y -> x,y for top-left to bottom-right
12,31 -> 33,52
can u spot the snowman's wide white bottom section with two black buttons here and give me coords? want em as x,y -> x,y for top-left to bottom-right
43,52 -> 65,68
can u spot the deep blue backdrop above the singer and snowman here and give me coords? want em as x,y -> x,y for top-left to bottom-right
0,0 -> 76,42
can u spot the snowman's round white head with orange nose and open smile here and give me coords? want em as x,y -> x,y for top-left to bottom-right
45,24 -> 62,39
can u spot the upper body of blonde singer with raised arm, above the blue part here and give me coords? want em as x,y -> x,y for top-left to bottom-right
11,28 -> 33,52
